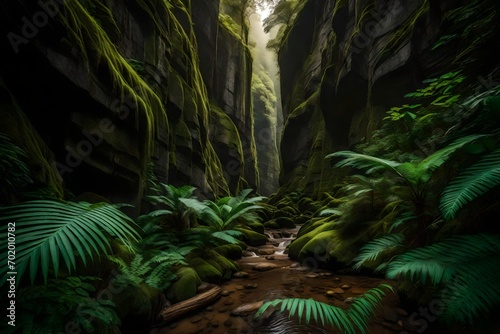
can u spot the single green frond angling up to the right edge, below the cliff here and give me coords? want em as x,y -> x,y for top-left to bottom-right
440,149 -> 500,220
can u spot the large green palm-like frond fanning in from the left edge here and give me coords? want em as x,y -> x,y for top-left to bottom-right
0,200 -> 140,282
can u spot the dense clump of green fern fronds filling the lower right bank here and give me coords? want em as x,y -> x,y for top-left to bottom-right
355,233 -> 500,323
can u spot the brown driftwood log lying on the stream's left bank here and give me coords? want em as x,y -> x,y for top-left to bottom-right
153,283 -> 221,327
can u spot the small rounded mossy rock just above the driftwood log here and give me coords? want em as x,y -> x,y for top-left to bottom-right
166,267 -> 201,303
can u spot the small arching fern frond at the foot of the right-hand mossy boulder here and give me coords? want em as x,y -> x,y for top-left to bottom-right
352,233 -> 405,270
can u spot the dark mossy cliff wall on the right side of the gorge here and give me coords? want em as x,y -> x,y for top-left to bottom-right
279,0 -> 459,194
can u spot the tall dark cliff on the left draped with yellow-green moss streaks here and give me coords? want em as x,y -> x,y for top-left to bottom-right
0,0 -> 259,207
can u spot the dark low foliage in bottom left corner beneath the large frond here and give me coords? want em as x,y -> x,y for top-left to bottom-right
2,277 -> 120,334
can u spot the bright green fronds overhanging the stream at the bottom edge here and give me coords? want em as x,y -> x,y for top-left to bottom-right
254,284 -> 394,334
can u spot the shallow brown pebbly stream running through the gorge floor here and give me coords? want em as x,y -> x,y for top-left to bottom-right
149,227 -> 408,334
